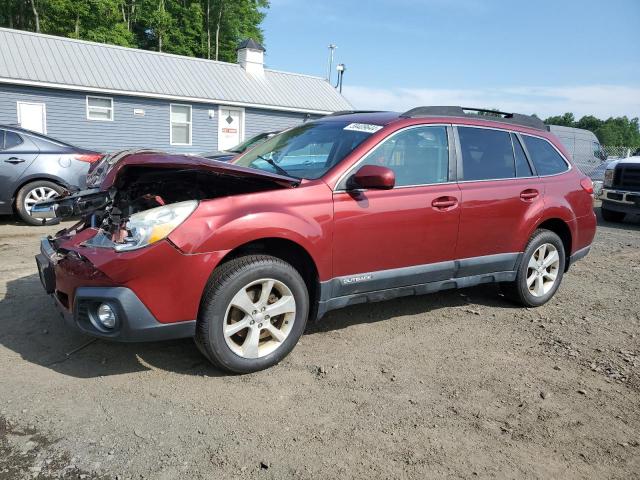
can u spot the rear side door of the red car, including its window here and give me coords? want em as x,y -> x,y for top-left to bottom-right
456,127 -> 544,268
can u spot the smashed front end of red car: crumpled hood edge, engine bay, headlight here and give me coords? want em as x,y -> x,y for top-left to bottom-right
32,151 -> 299,251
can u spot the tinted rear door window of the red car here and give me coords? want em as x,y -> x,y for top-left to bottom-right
458,127 -> 516,180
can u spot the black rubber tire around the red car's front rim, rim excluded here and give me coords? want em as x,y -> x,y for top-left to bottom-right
195,255 -> 309,373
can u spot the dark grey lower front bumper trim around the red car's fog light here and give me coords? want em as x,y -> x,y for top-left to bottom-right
36,238 -> 196,342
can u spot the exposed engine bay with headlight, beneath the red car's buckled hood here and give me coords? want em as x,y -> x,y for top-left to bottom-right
42,166 -> 296,251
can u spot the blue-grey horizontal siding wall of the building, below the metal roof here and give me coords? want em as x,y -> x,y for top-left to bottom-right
0,84 -> 317,153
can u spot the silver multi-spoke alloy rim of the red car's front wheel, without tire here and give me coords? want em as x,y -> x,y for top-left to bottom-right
223,278 -> 296,358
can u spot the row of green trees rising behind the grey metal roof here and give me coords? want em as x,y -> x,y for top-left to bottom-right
0,0 -> 269,62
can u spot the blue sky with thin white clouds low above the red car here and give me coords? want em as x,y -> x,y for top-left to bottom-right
263,0 -> 640,119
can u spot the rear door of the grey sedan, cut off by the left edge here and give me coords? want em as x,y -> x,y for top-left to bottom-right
0,130 -> 39,212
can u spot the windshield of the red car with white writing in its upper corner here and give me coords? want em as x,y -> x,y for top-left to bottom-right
232,121 -> 382,179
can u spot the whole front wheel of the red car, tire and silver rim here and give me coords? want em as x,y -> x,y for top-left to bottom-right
195,255 -> 309,373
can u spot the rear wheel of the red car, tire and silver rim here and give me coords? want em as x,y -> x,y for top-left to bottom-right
503,229 -> 565,307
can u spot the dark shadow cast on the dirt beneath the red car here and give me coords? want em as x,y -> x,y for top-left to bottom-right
0,274 -> 512,378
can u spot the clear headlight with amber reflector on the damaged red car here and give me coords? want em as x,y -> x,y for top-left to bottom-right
114,200 -> 198,252
